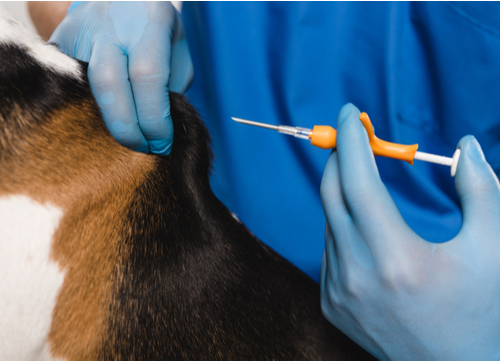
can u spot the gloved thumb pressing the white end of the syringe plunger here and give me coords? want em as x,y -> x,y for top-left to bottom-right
455,135 -> 500,230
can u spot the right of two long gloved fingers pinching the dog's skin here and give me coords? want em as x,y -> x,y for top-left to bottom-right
128,8 -> 179,155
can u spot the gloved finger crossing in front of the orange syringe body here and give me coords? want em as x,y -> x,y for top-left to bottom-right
337,104 -> 417,260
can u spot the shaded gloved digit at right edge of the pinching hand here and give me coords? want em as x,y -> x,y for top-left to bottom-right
168,10 -> 194,94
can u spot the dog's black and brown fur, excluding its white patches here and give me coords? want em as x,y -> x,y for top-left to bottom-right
0,12 -> 376,360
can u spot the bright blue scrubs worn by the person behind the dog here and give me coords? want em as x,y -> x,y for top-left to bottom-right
183,2 -> 500,280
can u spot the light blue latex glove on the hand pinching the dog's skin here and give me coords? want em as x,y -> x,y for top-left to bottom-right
50,2 -> 193,155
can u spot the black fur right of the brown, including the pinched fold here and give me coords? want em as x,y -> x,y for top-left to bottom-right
101,93 -> 369,360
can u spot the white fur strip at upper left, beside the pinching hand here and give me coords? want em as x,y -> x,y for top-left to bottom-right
0,5 -> 81,79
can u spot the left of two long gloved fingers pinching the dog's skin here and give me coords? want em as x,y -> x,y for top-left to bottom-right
88,44 -> 149,153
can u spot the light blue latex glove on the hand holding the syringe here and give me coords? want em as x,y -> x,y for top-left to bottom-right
321,104 -> 500,360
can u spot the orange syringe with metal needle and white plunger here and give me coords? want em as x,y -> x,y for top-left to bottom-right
231,113 -> 460,177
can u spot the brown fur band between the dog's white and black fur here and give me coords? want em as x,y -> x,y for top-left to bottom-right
0,96 -> 152,360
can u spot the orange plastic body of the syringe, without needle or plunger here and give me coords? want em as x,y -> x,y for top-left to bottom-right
309,112 -> 418,165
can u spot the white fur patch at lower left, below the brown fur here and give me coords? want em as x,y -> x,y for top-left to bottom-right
0,195 -> 64,360
